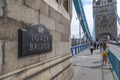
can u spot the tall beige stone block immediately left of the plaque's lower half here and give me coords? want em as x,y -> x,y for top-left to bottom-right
3,41 -> 18,73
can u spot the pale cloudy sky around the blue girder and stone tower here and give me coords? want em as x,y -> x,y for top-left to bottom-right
71,0 -> 120,38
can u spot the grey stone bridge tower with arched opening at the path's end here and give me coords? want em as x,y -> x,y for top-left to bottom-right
93,0 -> 117,40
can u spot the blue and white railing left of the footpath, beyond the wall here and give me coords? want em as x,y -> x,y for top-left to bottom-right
71,44 -> 88,56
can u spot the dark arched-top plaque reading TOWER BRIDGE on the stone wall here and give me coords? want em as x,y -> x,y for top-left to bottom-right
18,24 -> 52,57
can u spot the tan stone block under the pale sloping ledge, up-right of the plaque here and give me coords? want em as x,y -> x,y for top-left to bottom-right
49,7 -> 62,22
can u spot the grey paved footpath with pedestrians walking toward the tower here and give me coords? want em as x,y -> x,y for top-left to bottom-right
72,49 -> 114,80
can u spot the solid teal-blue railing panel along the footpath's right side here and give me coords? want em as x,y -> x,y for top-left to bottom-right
108,50 -> 120,80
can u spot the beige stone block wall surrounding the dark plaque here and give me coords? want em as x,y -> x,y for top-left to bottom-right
0,0 -> 73,80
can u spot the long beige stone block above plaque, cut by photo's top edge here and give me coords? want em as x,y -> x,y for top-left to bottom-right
25,0 -> 49,16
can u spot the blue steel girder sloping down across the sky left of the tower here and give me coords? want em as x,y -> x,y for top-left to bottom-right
73,0 -> 92,40
